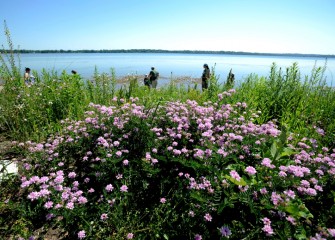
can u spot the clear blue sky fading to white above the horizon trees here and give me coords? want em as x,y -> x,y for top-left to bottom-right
0,0 -> 335,54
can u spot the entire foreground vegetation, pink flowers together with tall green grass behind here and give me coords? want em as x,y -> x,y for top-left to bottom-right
0,23 -> 335,239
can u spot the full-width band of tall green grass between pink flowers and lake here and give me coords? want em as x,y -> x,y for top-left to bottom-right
0,60 -> 335,146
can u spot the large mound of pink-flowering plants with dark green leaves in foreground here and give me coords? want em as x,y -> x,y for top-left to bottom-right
19,90 -> 335,239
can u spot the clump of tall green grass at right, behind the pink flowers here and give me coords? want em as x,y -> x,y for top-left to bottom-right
235,63 -> 335,145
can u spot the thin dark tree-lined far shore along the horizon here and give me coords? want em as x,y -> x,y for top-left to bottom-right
0,49 -> 335,58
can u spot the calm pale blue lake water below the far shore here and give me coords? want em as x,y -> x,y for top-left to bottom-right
12,53 -> 335,86
